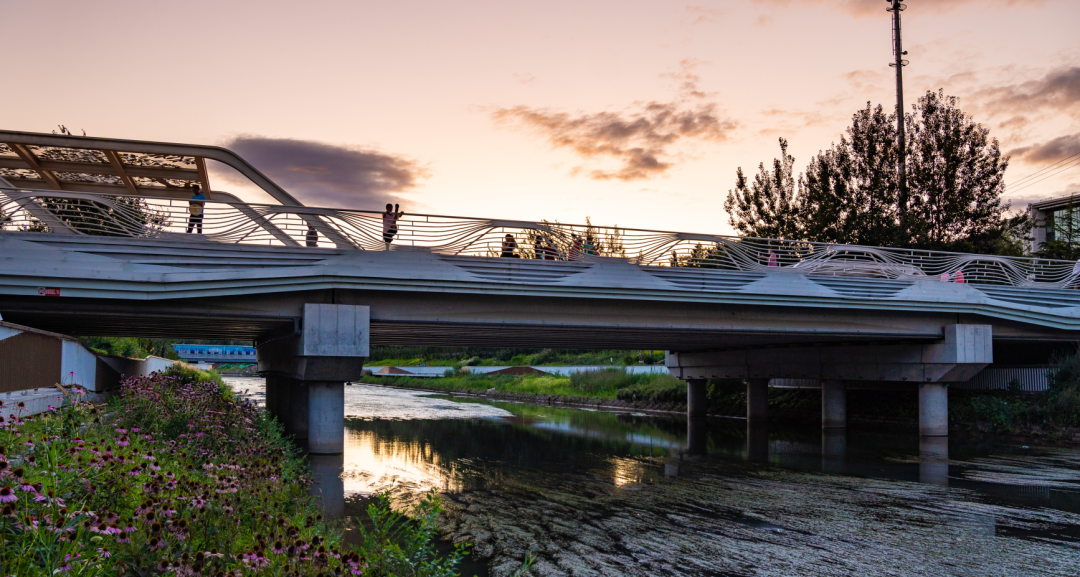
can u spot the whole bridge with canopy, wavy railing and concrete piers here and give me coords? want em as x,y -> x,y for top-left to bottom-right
0,131 -> 1080,453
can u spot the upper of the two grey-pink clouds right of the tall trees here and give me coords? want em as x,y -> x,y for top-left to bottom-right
972,66 -> 1080,116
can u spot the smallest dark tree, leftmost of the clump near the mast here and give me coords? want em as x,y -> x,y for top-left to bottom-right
724,138 -> 801,239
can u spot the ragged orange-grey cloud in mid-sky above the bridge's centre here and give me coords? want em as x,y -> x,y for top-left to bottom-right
491,59 -> 738,180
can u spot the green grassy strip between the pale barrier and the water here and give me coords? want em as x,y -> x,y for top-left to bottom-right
363,367 -> 686,403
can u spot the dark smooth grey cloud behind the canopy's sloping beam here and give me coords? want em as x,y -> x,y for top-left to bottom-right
216,134 -> 428,209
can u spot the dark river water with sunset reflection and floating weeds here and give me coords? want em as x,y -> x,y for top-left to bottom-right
229,379 -> 1080,576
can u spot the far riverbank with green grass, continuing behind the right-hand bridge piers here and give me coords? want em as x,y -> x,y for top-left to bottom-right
360,371 -> 1080,443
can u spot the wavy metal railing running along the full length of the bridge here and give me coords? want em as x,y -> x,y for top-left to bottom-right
0,187 -> 1080,289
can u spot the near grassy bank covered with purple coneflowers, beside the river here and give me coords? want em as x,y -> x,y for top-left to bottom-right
0,367 -> 457,577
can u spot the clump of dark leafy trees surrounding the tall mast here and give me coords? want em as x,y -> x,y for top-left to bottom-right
724,91 -> 1030,254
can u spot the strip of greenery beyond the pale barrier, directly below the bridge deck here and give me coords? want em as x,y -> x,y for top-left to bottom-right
364,347 -> 664,368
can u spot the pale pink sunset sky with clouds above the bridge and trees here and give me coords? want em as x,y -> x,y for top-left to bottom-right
0,0 -> 1080,233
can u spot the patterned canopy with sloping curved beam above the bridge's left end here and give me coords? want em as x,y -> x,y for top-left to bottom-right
0,131 -> 302,206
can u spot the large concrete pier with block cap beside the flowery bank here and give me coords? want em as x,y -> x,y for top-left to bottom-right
256,304 -> 370,455
